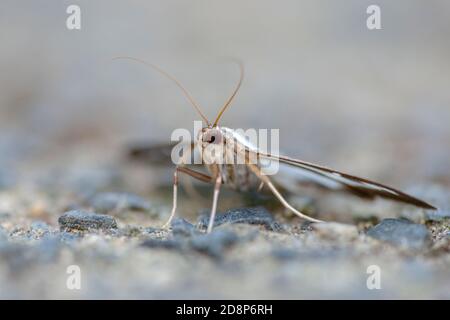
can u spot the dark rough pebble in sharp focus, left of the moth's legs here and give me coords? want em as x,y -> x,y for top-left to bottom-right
58,210 -> 117,231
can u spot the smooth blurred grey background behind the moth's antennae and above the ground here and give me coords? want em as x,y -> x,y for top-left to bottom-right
0,0 -> 450,186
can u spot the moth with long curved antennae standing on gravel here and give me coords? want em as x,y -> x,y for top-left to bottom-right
118,57 -> 436,233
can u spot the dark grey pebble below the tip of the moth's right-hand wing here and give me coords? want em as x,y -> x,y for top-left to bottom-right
367,219 -> 430,249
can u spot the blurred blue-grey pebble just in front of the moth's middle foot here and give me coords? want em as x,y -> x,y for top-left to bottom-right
190,230 -> 239,258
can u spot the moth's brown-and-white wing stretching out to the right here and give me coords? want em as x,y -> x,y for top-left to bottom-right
259,153 -> 436,210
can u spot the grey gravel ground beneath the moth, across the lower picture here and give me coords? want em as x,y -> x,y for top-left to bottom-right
0,169 -> 450,299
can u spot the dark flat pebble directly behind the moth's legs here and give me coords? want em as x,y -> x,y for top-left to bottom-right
198,207 -> 283,231
